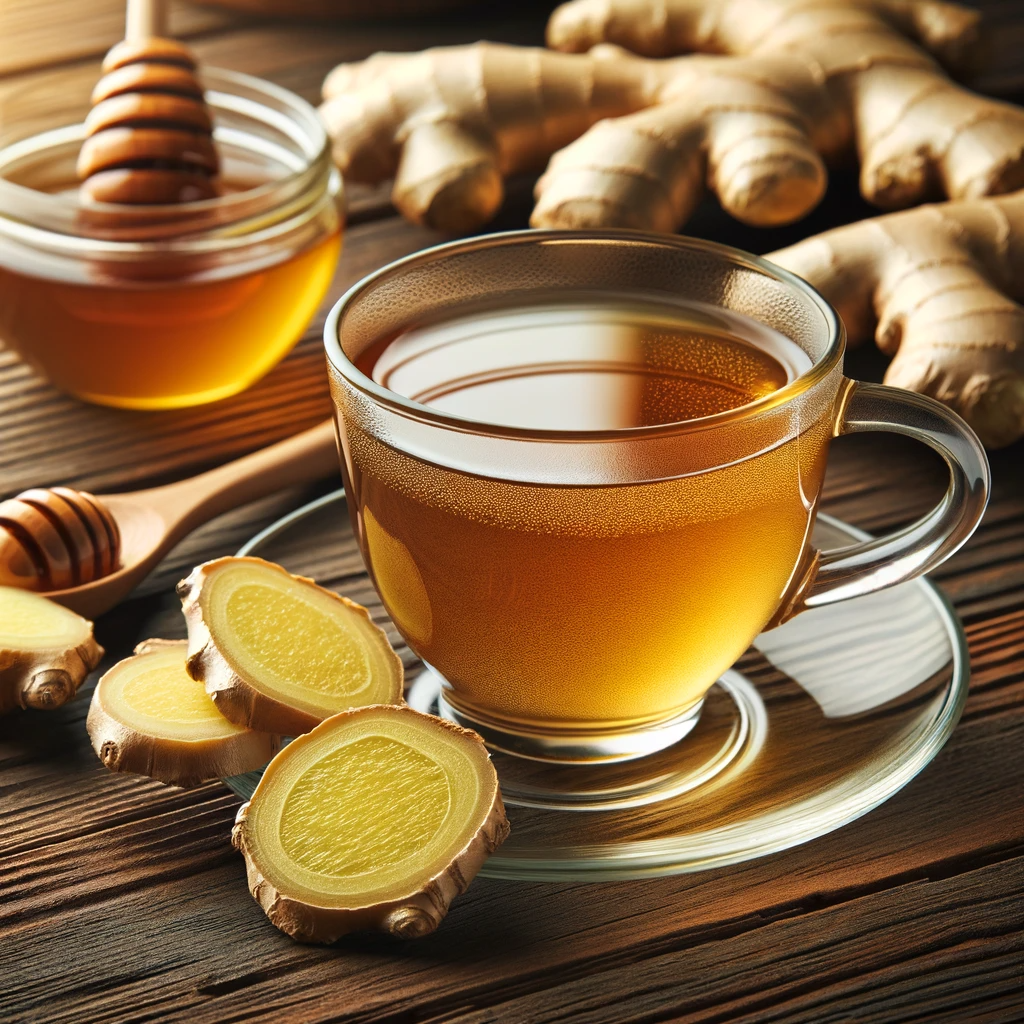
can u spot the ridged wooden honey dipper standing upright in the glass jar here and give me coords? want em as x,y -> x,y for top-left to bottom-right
78,0 -> 219,204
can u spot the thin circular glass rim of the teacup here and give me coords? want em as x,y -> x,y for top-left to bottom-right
324,228 -> 846,441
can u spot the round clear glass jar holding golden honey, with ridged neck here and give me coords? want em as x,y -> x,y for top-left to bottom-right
0,68 -> 342,409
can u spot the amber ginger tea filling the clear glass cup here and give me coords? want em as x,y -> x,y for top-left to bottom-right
343,296 -> 831,728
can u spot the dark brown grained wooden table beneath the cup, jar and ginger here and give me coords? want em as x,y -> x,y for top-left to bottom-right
0,0 -> 1024,1024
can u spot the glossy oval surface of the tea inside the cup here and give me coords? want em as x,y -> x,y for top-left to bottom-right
360,299 -> 810,431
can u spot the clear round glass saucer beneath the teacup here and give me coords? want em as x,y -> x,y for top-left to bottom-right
225,490 -> 968,882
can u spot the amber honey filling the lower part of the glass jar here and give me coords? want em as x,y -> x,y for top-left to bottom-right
0,231 -> 339,409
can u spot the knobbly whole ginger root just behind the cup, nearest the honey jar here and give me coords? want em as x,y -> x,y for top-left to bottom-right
321,43 -> 846,231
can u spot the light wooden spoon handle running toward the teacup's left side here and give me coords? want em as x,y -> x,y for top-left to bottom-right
137,420 -> 340,540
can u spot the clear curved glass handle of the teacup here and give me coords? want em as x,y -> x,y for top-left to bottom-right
771,381 -> 991,625
